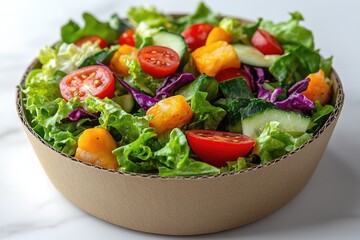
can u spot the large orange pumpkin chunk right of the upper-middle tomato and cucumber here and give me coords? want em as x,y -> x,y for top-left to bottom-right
191,41 -> 240,76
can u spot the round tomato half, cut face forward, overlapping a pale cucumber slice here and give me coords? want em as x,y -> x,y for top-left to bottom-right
138,46 -> 180,78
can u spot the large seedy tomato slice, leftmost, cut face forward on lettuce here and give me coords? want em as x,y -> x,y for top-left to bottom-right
60,66 -> 115,101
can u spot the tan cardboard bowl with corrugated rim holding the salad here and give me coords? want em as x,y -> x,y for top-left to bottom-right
17,49 -> 344,235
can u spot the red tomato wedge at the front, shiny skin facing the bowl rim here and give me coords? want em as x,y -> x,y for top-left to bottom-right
185,130 -> 255,167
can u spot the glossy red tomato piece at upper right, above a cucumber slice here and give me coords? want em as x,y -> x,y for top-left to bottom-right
251,29 -> 284,55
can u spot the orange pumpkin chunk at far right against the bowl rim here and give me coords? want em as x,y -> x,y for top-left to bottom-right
302,69 -> 331,105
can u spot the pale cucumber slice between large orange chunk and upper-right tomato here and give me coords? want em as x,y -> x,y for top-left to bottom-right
233,44 -> 281,67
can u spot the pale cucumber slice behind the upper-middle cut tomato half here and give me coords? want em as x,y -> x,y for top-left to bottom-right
153,30 -> 188,62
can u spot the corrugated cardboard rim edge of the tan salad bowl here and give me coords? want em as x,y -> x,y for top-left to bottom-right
16,45 -> 345,179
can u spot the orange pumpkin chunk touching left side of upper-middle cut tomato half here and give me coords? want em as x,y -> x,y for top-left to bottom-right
110,44 -> 137,76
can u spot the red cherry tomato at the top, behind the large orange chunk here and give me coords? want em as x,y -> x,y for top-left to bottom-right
181,23 -> 214,52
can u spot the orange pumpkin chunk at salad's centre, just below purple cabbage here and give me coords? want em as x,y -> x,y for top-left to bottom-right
146,95 -> 194,136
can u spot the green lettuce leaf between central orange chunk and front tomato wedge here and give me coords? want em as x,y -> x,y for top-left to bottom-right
189,91 -> 226,130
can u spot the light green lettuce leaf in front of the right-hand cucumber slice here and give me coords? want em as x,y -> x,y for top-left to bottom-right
256,121 -> 312,164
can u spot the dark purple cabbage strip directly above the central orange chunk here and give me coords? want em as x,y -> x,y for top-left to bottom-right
155,73 -> 195,100
